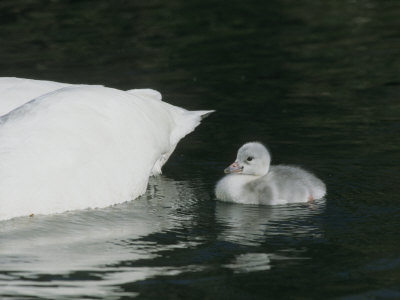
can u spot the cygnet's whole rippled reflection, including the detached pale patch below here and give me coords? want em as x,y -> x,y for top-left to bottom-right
215,199 -> 325,273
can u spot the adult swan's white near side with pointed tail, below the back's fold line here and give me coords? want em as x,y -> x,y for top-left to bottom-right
0,82 -> 211,220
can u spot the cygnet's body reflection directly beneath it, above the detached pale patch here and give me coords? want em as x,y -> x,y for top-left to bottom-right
215,200 -> 325,246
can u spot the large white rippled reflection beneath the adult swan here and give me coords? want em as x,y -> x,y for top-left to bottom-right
0,177 -> 203,299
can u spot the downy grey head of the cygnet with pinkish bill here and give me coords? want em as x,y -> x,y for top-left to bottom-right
225,142 -> 271,176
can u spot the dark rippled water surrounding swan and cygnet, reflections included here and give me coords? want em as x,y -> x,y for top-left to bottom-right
0,0 -> 400,300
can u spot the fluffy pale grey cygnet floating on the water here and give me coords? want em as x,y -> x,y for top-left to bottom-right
215,142 -> 326,205
